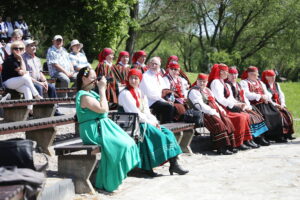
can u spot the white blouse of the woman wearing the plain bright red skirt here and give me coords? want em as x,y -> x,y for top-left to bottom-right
210,79 -> 236,108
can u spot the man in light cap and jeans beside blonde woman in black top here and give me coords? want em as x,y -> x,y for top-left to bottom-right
22,39 -> 63,116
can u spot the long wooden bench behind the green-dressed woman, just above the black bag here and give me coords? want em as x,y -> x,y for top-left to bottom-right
0,115 -> 75,155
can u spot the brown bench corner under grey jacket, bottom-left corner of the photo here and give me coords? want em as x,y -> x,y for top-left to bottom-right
0,185 -> 24,200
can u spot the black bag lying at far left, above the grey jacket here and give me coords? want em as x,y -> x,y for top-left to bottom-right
0,138 -> 48,171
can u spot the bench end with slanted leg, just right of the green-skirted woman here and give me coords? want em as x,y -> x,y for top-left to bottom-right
162,122 -> 195,154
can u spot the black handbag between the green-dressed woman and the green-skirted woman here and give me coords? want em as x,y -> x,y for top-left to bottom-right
111,112 -> 142,142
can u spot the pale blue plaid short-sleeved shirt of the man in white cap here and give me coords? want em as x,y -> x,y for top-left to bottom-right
47,46 -> 73,77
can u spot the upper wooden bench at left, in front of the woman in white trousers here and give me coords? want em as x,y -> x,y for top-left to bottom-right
0,98 -> 75,122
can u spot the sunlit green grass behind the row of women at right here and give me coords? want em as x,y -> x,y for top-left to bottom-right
187,72 -> 300,137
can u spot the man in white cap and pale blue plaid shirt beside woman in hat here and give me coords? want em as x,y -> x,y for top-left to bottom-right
47,35 -> 76,96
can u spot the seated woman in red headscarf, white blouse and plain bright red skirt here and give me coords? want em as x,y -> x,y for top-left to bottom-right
208,64 -> 252,150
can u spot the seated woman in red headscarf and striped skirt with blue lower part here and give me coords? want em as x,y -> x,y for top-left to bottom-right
226,67 -> 268,148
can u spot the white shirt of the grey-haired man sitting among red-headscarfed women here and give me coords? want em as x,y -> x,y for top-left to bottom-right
140,70 -> 167,106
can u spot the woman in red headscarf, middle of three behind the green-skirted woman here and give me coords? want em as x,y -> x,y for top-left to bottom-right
115,51 -> 130,85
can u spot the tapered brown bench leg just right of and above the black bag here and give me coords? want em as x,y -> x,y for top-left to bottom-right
25,127 -> 56,156
